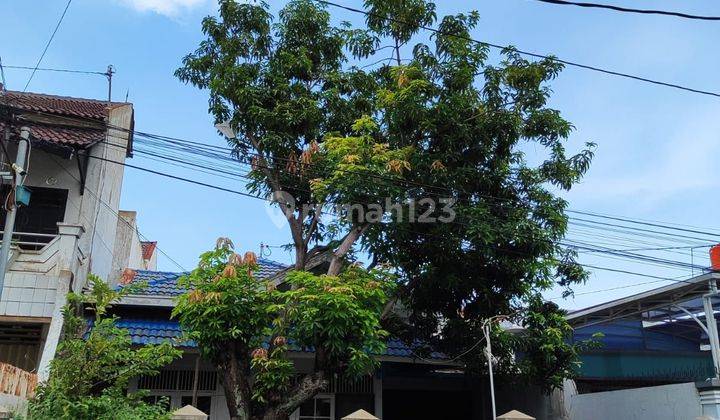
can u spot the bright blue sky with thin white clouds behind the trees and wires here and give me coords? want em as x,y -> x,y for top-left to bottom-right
0,0 -> 720,309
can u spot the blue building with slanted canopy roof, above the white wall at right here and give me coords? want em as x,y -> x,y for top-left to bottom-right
567,273 -> 720,393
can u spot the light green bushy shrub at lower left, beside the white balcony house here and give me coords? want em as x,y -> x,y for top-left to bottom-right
29,275 -> 182,420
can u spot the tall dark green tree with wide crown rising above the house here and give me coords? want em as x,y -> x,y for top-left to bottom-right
176,0 -> 594,406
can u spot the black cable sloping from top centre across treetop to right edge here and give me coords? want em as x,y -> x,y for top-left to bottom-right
315,0 -> 720,98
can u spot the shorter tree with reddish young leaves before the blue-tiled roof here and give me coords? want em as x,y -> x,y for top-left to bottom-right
173,239 -> 394,420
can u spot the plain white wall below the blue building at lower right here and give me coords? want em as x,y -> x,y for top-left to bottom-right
565,383 -> 702,420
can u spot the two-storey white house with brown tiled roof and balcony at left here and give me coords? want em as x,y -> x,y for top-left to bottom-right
0,86 -> 135,379
